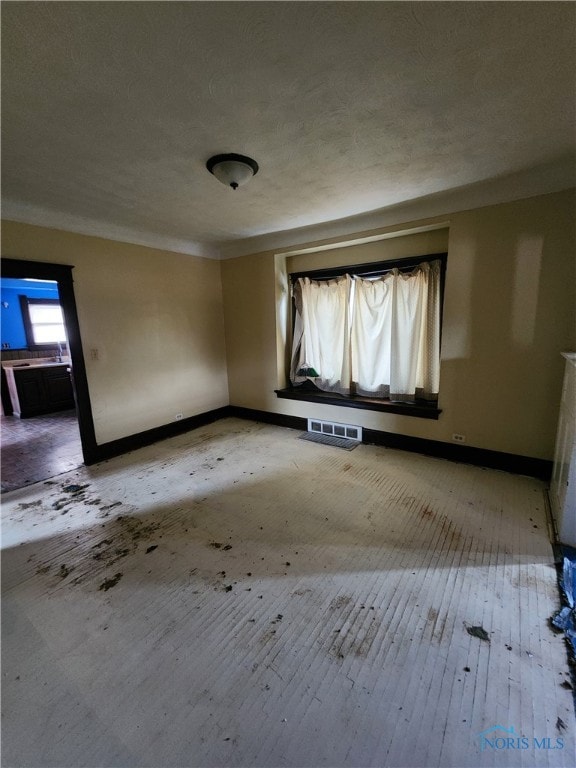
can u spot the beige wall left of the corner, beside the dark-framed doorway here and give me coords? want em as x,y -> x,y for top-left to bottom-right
2,222 -> 228,444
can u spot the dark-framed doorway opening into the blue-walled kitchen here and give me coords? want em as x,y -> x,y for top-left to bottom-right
2,259 -> 96,491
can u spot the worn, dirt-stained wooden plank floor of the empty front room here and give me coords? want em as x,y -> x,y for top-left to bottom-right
2,419 -> 576,768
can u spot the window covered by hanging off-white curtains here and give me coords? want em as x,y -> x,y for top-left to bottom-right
282,254 -> 446,416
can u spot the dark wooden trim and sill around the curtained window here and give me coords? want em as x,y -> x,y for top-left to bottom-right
282,251 -> 448,419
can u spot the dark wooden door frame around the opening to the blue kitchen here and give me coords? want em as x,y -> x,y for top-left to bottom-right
1,258 -> 98,464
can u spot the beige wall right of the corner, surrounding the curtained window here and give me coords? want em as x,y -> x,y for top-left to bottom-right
222,191 -> 576,459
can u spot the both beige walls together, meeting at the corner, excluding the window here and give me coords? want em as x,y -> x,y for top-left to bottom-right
2,191 -> 576,459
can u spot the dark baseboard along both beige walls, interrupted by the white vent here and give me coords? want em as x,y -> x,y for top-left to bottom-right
85,405 -> 552,480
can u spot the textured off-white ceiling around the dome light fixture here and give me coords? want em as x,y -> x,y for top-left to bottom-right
2,2 -> 576,256
